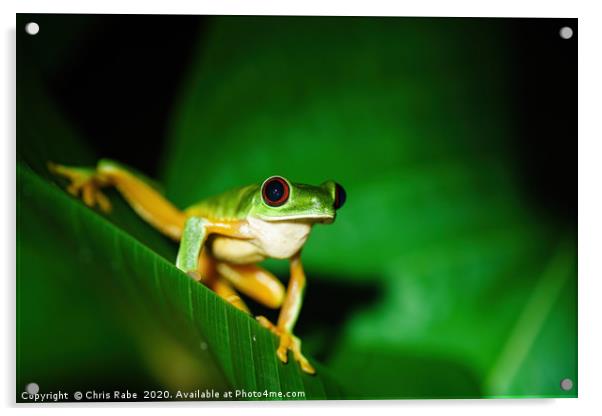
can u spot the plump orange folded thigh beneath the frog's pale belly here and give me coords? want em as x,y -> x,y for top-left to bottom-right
215,262 -> 285,309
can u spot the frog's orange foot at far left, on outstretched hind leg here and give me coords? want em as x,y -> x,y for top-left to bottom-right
48,162 -> 111,213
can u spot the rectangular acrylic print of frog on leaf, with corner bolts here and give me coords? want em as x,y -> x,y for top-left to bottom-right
16,14 -> 578,402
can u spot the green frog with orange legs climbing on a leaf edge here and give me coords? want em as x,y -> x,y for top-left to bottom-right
48,159 -> 347,374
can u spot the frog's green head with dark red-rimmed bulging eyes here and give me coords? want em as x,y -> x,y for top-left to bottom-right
252,176 -> 346,223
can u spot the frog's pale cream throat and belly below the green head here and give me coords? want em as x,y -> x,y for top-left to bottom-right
211,217 -> 311,264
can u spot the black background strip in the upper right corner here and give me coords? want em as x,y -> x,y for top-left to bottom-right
506,19 -> 579,227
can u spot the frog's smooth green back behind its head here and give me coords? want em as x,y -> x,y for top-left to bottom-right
184,184 -> 259,221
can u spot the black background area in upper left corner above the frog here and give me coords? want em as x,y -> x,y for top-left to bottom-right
17,14 -> 207,177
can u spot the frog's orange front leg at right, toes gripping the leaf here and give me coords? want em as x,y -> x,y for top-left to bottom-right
257,253 -> 316,374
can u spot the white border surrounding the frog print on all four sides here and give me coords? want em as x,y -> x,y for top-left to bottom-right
0,0 -> 602,416
